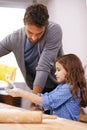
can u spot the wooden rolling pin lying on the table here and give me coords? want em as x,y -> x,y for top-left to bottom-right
0,108 -> 57,123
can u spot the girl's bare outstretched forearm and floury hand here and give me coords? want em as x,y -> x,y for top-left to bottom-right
6,88 -> 42,105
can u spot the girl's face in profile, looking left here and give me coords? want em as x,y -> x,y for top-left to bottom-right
55,62 -> 67,83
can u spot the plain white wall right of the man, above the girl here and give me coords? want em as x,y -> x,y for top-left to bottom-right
47,0 -> 87,65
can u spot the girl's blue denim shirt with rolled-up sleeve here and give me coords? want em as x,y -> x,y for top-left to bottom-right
39,84 -> 80,121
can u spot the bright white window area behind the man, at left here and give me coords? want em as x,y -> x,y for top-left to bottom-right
0,7 -> 25,82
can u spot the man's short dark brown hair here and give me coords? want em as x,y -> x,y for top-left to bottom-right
24,4 -> 49,27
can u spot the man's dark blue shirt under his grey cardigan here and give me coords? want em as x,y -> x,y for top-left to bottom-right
24,39 -> 39,74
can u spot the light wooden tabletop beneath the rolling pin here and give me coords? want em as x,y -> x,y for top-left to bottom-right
0,103 -> 87,130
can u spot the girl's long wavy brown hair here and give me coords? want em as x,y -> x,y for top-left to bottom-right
56,54 -> 87,107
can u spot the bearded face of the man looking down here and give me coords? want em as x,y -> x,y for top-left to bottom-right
25,24 -> 45,44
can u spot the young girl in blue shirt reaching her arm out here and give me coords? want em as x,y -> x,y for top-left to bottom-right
6,54 -> 87,121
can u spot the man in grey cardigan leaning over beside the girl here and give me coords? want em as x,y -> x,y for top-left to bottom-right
0,4 -> 63,109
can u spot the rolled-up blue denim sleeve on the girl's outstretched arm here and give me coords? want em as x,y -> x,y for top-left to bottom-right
39,84 -> 72,110
